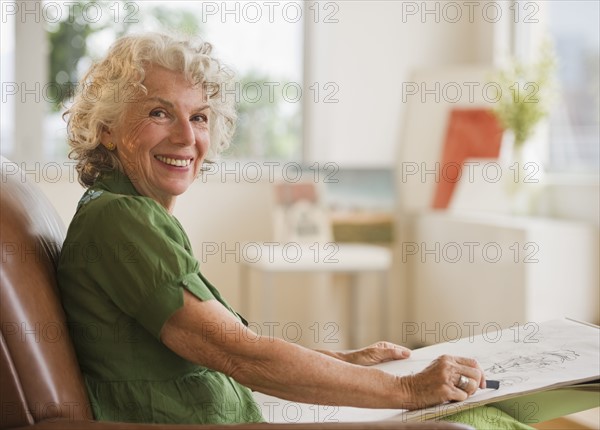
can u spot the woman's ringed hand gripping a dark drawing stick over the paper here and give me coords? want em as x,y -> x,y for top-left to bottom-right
400,355 -> 485,409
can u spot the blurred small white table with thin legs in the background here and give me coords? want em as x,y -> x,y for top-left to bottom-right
240,242 -> 392,348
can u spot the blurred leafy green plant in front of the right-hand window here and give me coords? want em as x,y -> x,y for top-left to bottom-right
490,41 -> 556,148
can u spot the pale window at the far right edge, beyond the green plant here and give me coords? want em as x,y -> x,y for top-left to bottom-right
542,0 -> 600,172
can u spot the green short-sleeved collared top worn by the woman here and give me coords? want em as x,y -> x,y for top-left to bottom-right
58,172 -> 264,424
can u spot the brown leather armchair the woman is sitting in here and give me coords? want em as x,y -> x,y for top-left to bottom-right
0,158 -> 468,430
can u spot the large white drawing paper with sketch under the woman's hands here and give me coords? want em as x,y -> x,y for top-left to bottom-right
254,319 -> 600,423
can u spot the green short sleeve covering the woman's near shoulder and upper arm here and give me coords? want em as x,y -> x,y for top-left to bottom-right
68,195 -> 215,338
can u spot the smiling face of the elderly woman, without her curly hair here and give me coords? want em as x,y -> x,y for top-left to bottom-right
102,65 -> 210,212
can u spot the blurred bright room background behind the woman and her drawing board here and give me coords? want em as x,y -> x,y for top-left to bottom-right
0,1 -> 600,380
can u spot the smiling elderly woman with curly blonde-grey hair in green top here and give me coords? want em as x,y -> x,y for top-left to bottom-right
58,34 -> 528,423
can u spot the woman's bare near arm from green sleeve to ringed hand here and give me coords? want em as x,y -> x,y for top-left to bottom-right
161,291 -> 485,409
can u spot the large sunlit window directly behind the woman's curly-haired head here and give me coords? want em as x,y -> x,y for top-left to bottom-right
46,1 -> 303,160
